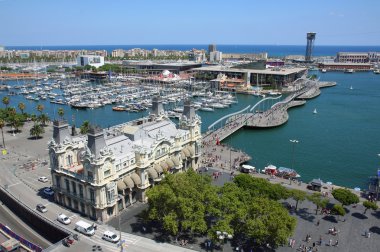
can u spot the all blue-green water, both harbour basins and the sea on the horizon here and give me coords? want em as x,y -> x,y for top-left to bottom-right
0,45 -> 380,189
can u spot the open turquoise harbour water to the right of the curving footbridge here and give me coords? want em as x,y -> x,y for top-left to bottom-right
225,73 -> 380,188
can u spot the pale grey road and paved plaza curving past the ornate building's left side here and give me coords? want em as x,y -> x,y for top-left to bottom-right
0,123 -> 196,252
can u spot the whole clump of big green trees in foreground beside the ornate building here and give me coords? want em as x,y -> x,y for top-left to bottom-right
147,172 -> 296,247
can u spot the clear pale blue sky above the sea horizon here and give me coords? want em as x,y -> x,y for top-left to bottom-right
0,0 -> 380,46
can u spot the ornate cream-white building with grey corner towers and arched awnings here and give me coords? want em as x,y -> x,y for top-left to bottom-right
49,98 -> 201,221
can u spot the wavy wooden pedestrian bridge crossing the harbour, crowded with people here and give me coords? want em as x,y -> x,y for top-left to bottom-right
203,79 -> 336,142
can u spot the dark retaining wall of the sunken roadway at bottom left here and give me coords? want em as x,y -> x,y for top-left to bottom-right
0,187 -> 70,243
